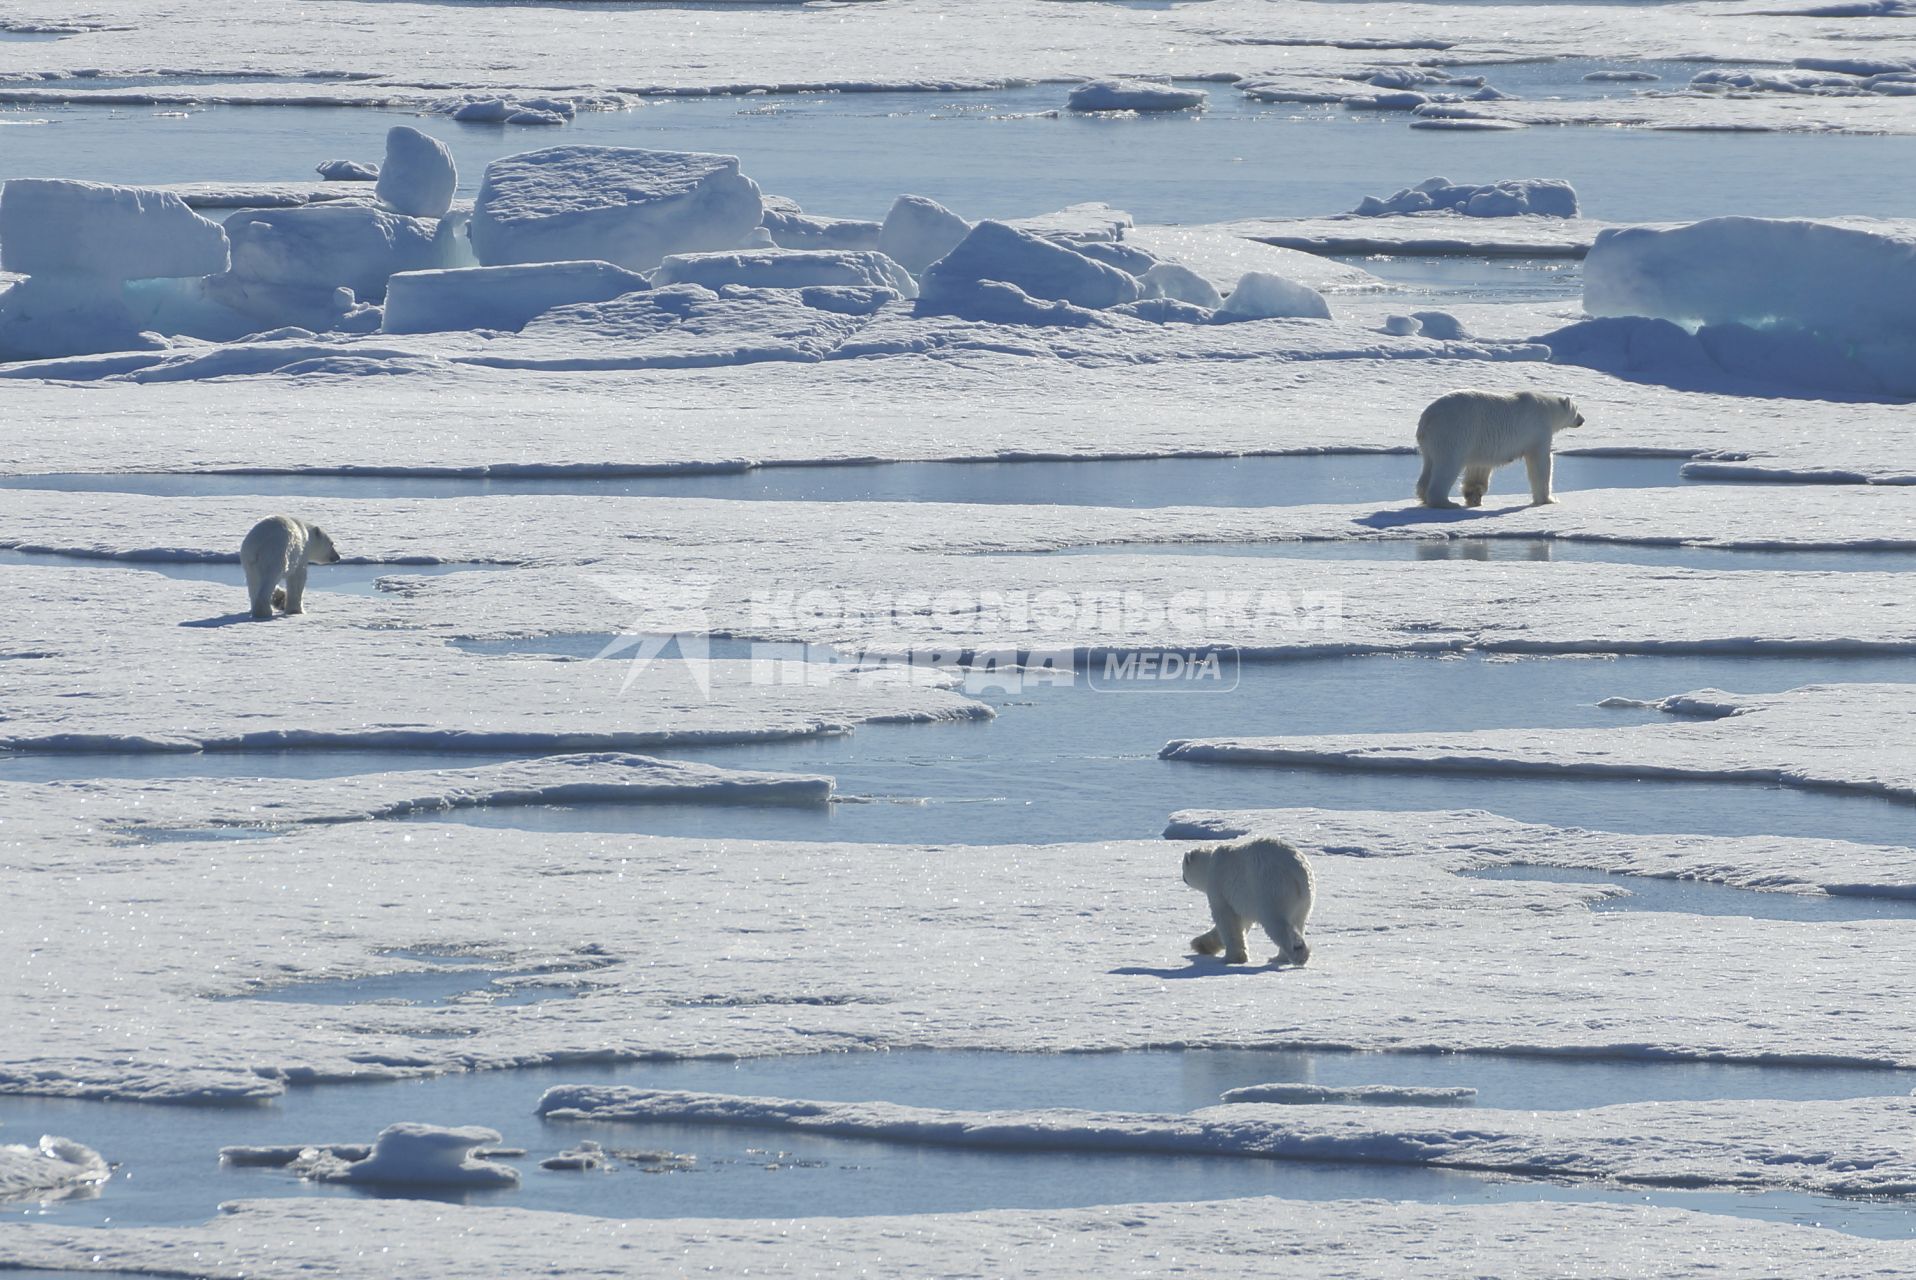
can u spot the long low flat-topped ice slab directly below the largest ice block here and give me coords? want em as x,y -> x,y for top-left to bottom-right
379,263 -> 651,333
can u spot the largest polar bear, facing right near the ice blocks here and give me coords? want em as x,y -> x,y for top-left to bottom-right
1418,391 -> 1583,506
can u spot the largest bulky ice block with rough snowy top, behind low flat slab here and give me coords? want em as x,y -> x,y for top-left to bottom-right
469,146 -> 764,270
